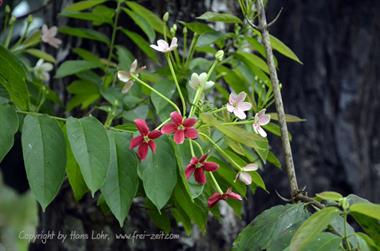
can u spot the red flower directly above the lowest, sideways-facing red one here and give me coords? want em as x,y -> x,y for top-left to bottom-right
185,154 -> 219,185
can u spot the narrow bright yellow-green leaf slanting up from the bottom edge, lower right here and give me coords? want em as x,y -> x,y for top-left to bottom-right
290,207 -> 340,251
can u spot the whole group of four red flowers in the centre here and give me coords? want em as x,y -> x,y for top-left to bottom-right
131,112 -> 241,207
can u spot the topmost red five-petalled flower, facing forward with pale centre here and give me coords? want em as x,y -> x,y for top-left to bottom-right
161,112 -> 198,144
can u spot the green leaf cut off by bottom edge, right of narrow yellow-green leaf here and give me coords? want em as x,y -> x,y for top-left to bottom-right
302,233 -> 344,251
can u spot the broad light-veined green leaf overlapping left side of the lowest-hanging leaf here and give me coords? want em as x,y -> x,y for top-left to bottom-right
66,117 -> 110,196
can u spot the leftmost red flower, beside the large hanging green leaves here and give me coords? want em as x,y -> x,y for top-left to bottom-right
129,119 -> 162,160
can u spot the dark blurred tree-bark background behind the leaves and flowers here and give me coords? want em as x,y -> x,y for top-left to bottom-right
2,0 -> 380,250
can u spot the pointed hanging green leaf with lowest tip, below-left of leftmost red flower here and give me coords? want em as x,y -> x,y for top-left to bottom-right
101,131 -> 139,227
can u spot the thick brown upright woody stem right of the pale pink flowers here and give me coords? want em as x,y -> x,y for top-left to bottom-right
256,0 -> 299,199
